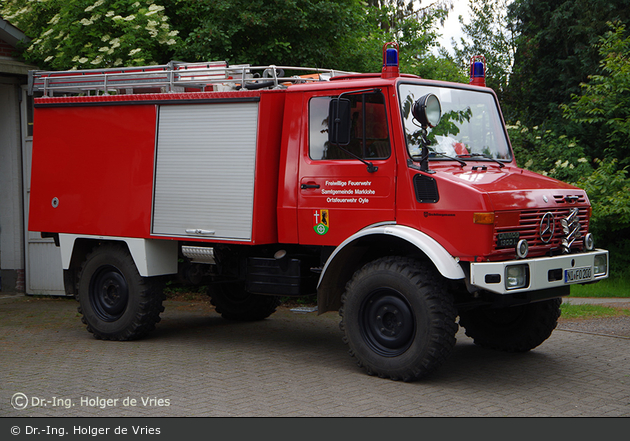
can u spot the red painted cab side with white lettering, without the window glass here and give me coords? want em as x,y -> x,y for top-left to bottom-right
278,82 -> 397,246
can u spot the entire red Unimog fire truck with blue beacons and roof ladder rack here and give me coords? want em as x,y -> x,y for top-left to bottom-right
29,43 -> 608,381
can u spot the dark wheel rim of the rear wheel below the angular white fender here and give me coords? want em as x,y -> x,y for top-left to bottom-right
90,265 -> 129,322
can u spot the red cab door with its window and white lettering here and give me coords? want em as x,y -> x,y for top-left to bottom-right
297,91 -> 396,246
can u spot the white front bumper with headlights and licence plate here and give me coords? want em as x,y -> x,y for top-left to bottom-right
470,249 -> 610,294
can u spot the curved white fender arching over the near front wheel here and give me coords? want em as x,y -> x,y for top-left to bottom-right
317,224 -> 466,314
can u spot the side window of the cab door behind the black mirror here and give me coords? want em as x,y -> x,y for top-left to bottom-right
309,92 -> 391,160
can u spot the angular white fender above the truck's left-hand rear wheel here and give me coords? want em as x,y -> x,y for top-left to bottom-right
59,234 -> 177,277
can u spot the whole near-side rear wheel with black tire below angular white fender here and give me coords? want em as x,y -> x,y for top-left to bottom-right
78,244 -> 164,341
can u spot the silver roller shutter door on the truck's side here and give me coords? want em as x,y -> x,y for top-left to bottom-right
152,100 -> 259,241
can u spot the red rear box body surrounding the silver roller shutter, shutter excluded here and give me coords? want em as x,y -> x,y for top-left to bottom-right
29,91 -> 285,244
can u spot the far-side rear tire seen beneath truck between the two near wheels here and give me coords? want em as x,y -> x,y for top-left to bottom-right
210,283 -> 280,321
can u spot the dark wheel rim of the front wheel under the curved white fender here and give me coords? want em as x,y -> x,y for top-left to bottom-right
360,288 -> 416,357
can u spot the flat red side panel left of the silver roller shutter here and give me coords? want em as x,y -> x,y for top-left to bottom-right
29,105 -> 156,237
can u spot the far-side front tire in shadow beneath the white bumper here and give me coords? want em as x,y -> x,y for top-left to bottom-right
459,299 -> 562,352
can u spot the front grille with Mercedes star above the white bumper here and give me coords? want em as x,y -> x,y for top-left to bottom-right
492,204 -> 589,257
